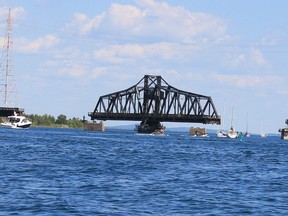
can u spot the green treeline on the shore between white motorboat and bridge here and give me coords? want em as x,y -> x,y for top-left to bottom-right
25,114 -> 83,128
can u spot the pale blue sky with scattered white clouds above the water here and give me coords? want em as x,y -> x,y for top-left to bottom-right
0,0 -> 288,133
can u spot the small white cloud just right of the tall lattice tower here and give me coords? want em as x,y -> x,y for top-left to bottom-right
14,34 -> 60,53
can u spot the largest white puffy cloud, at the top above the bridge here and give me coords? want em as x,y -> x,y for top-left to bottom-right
66,0 -> 226,42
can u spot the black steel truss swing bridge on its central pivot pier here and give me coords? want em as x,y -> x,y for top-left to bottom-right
88,75 -> 221,132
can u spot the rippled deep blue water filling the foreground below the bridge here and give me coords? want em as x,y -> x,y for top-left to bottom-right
0,128 -> 288,215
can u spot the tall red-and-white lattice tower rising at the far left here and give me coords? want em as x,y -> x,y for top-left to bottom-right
1,8 -> 17,107
